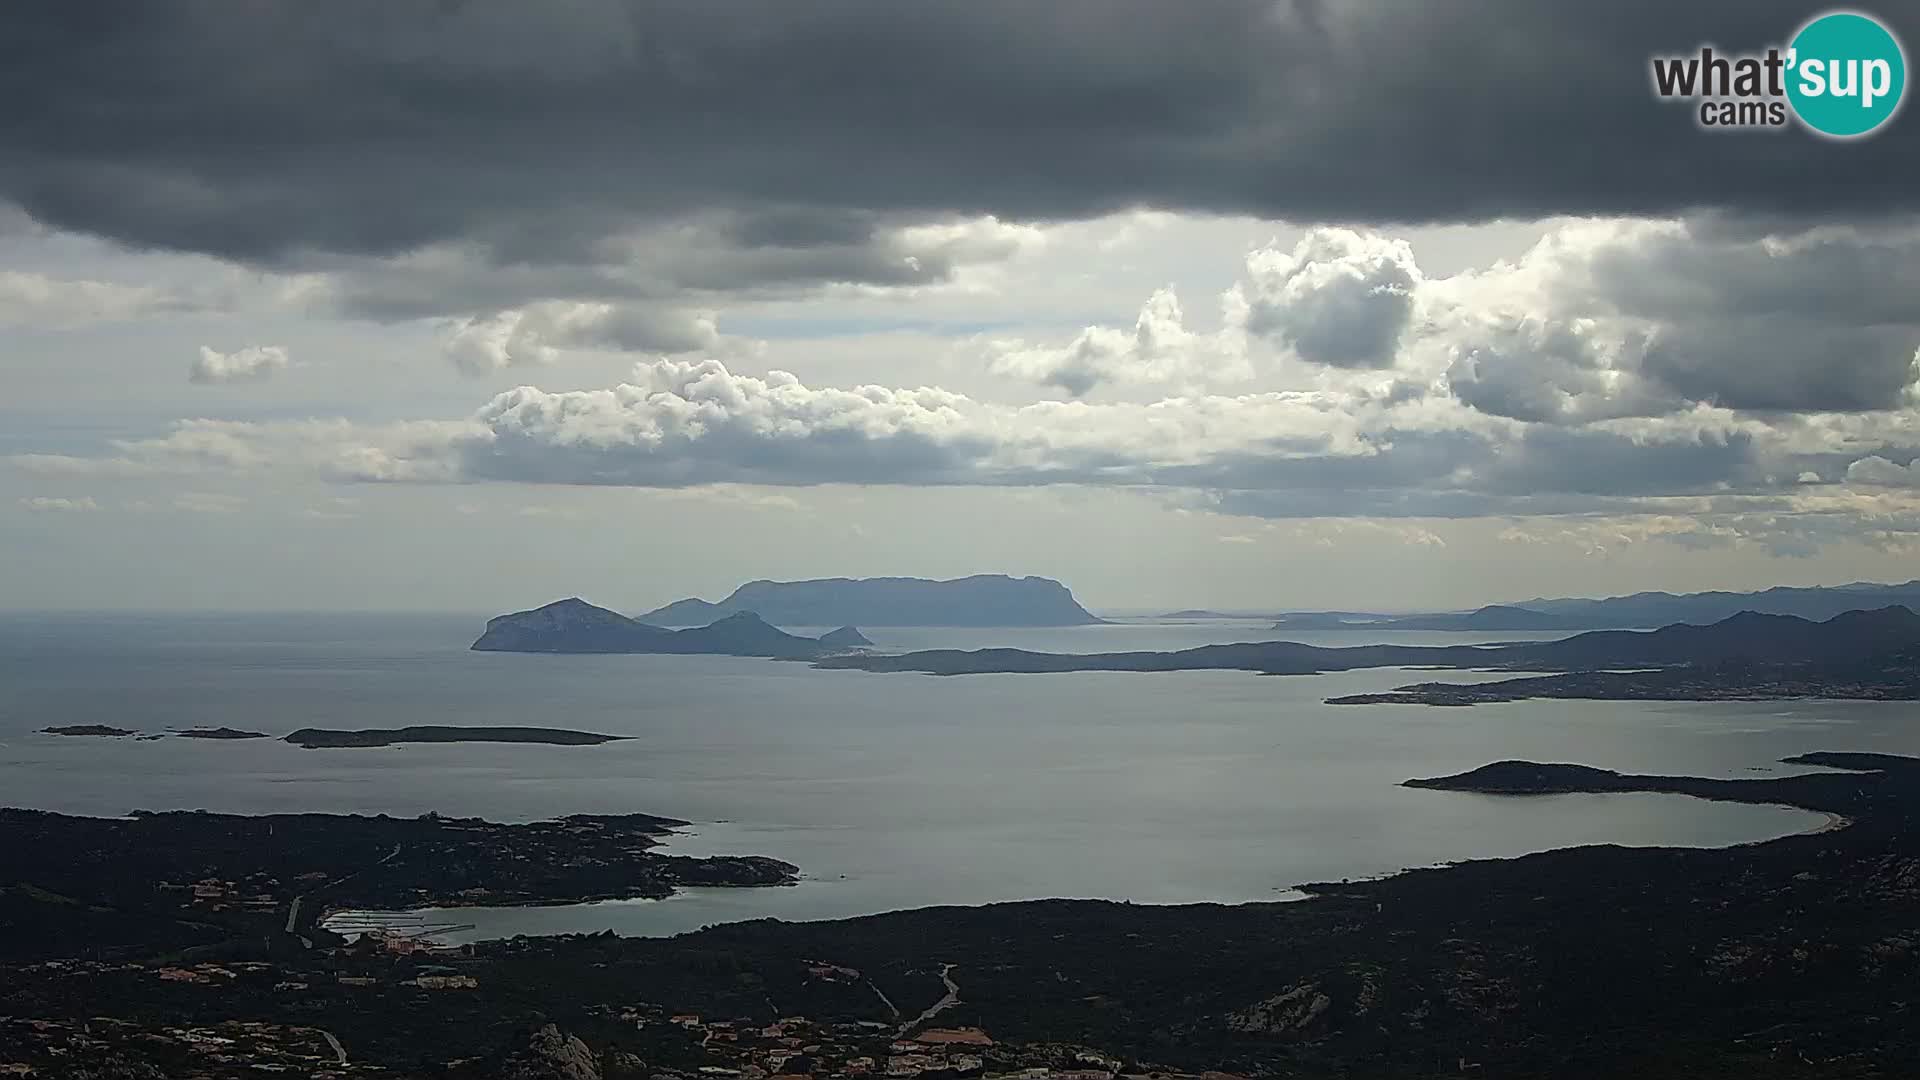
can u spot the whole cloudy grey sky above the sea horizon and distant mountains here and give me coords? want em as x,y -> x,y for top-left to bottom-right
0,0 -> 1920,611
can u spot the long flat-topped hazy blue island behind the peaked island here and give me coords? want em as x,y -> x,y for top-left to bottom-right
639,575 -> 1102,626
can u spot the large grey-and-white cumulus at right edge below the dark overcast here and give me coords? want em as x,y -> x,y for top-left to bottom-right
1428,217 -> 1920,425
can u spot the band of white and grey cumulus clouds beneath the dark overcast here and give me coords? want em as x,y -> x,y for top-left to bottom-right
26,219 -> 1920,532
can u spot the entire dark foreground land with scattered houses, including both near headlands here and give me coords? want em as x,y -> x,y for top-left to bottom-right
0,753 -> 1920,1080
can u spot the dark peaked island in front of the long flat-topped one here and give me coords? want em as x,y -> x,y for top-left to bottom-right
470,596 -> 864,659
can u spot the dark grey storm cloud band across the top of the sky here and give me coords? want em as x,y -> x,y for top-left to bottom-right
0,0 -> 1920,265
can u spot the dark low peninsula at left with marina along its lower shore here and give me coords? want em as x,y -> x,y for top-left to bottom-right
0,809 -> 799,960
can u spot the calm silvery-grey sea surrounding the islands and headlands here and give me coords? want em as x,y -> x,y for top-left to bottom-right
0,613 -> 1920,940
